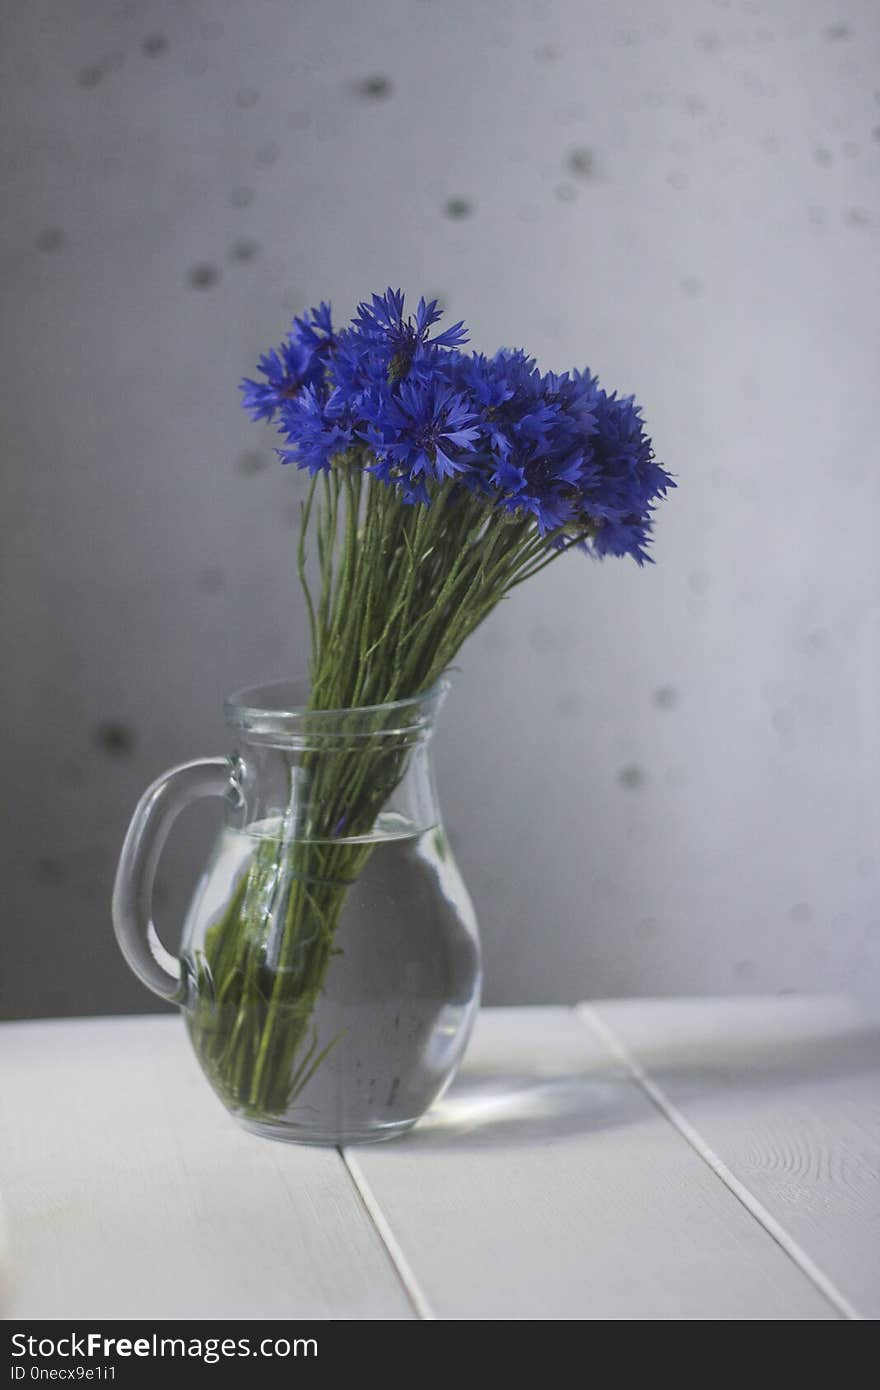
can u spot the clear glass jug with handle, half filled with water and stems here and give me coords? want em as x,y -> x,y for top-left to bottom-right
113,680 -> 481,1144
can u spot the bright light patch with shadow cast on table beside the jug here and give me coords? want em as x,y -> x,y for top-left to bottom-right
402,1072 -> 646,1150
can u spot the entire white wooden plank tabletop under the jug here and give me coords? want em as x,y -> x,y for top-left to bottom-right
0,998 -> 880,1321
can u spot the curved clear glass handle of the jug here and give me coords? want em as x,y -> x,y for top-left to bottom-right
113,758 -> 234,1001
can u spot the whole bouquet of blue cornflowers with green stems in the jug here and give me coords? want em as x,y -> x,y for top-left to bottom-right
190,289 -> 673,1115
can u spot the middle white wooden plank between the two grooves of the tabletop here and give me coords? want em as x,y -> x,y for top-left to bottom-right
346,1008 -> 838,1321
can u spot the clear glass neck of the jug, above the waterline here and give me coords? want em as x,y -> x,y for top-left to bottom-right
227,681 -> 448,842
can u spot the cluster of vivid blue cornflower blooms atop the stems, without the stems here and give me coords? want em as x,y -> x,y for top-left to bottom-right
236,289 -> 674,564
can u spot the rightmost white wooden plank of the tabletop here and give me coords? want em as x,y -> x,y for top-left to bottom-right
585,997 -> 880,1319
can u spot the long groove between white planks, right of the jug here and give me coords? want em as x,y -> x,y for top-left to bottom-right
574,1004 -> 865,1322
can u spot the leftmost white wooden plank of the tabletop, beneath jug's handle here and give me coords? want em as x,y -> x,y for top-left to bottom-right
0,1017 -> 414,1319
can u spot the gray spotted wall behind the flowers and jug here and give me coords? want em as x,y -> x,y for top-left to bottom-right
0,0 -> 880,1017
